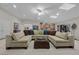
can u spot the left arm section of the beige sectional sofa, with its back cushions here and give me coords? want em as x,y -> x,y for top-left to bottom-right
6,32 -> 31,49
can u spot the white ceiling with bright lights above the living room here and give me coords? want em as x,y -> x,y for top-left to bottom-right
0,3 -> 79,22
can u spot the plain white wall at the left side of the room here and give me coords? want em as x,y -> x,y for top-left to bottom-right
0,10 -> 19,38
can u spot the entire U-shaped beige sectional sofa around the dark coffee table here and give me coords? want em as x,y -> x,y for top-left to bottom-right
6,30 -> 74,49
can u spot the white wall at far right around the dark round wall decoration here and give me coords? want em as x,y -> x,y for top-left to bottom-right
58,17 -> 79,40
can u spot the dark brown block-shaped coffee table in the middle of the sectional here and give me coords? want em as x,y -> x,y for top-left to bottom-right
34,39 -> 50,49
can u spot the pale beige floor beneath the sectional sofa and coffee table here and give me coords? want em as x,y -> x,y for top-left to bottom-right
0,39 -> 79,55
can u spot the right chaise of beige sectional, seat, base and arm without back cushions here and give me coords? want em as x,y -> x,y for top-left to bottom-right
48,35 -> 74,48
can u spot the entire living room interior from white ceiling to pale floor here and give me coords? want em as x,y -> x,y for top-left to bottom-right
0,3 -> 79,55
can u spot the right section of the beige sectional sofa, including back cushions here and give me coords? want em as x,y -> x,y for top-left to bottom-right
48,32 -> 74,48
